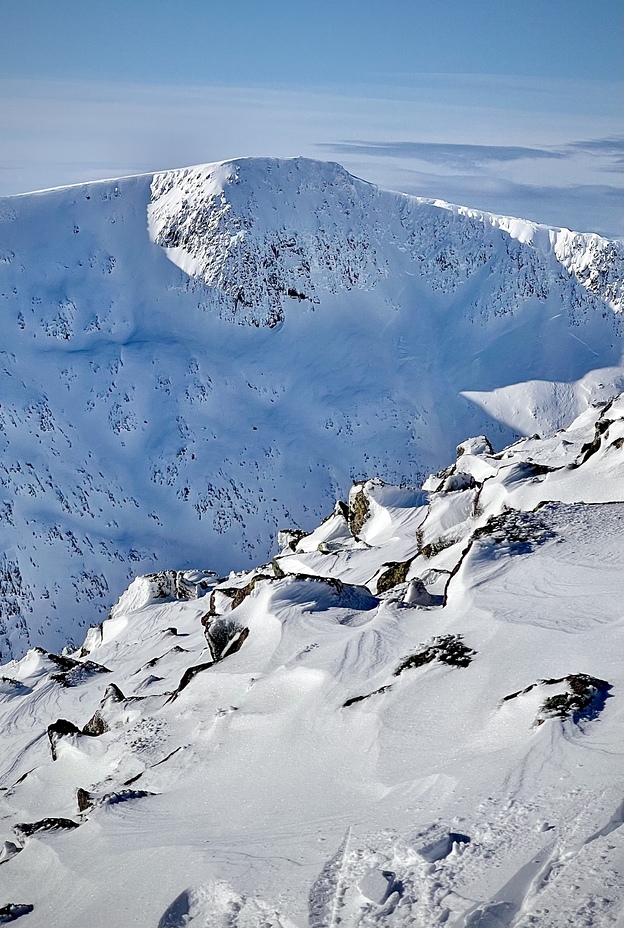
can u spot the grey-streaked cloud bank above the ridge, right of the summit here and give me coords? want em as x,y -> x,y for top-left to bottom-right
318,135 -> 624,237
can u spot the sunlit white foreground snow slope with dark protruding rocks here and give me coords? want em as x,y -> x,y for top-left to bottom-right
0,397 -> 624,928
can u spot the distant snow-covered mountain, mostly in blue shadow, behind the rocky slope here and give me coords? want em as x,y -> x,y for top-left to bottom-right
0,159 -> 624,658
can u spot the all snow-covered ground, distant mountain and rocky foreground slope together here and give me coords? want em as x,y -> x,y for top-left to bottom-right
0,158 -> 624,928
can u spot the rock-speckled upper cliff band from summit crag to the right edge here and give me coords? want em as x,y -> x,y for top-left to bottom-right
148,158 -> 624,326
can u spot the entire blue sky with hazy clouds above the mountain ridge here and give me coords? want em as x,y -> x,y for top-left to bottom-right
0,0 -> 624,235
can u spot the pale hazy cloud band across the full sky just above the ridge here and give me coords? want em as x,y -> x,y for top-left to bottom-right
0,78 -> 624,236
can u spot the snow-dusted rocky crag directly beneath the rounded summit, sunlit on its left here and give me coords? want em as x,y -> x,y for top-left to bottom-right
149,158 -> 386,327
